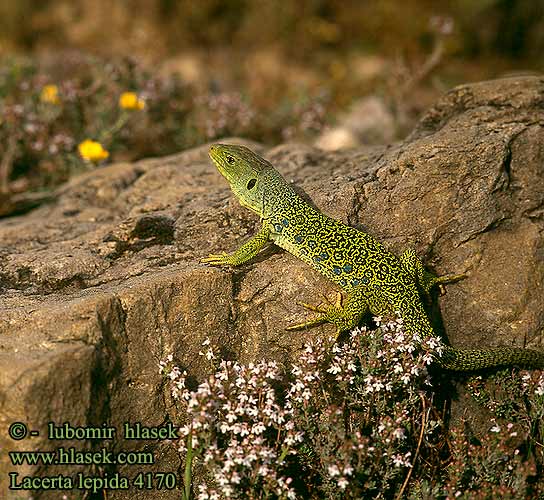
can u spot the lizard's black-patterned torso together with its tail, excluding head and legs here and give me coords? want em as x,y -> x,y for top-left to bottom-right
263,164 -> 544,371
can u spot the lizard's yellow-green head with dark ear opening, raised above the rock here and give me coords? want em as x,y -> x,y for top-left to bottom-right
210,144 -> 285,218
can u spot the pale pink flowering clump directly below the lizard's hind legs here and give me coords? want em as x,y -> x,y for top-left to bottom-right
286,318 -> 442,498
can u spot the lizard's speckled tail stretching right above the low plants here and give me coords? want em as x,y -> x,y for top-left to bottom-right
435,346 -> 544,371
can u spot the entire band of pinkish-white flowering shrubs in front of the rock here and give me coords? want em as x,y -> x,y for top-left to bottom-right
160,318 -> 544,500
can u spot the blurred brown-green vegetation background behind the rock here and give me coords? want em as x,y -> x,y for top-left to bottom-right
0,0 -> 544,209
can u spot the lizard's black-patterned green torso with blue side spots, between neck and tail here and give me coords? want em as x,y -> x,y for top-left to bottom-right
267,192 -> 424,322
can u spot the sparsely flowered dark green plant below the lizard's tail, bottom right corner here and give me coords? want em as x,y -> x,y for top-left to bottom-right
443,369 -> 544,500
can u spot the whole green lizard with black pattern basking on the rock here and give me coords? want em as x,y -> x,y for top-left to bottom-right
202,144 -> 544,371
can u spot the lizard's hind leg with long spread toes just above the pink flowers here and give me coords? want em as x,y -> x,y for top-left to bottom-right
286,290 -> 368,336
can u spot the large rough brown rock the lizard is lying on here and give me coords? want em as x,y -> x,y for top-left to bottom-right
0,77 -> 544,499
